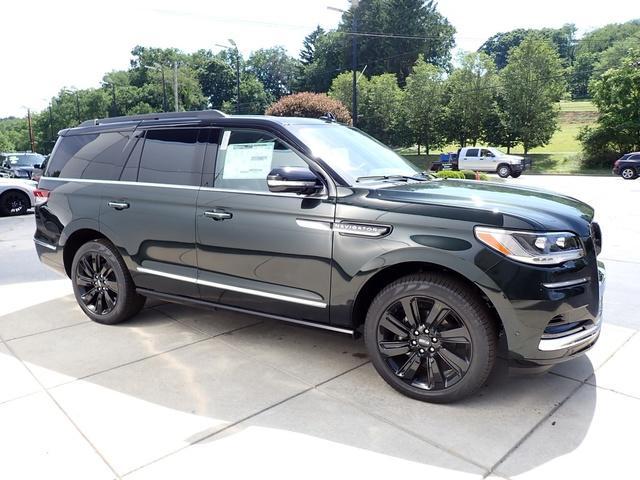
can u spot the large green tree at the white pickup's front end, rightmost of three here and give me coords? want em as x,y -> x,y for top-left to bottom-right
500,35 -> 565,155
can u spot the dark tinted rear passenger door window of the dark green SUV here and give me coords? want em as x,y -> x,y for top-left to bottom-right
138,128 -> 206,186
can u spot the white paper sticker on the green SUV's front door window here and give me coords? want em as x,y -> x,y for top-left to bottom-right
222,142 -> 275,180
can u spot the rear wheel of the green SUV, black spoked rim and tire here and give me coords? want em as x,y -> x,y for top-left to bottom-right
71,239 -> 146,325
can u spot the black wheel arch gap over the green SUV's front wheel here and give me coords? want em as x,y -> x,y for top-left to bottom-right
351,260 -> 504,338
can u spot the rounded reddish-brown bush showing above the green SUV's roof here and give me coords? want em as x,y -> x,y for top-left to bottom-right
264,92 -> 351,124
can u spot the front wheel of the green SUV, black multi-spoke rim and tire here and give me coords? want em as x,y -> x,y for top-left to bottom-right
364,273 -> 497,403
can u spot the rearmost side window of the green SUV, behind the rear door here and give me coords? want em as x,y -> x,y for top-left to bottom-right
46,132 -> 130,180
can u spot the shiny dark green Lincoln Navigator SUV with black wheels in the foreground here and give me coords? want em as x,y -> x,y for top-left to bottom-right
34,111 -> 604,402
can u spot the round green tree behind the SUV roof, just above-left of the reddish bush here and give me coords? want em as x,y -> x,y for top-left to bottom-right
247,46 -> 298,99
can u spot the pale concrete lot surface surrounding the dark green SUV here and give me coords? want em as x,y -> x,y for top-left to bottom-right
0,176 -> 640,480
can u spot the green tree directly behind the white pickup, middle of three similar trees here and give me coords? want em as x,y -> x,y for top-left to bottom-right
444,52 -> 498,147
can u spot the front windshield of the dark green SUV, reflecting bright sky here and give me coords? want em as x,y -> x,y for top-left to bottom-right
289,124 -> 420,185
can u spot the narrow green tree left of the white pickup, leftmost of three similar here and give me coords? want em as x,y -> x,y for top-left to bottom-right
404,56 -> 445,155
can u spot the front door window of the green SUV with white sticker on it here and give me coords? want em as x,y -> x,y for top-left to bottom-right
214,130 -> 307,192
